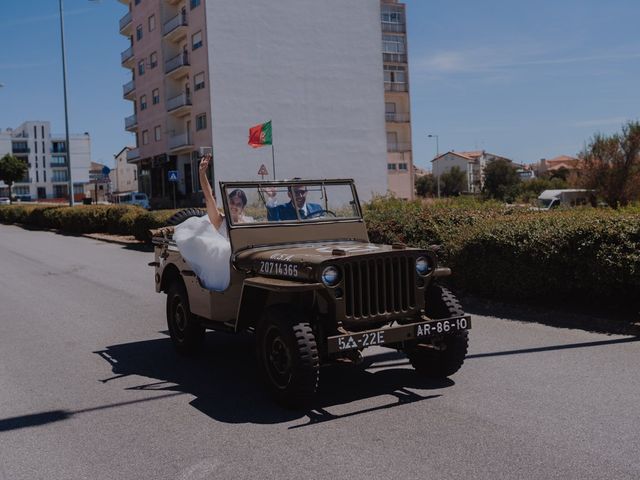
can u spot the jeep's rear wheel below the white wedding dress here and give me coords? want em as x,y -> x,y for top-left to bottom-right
167,281 -> 205,355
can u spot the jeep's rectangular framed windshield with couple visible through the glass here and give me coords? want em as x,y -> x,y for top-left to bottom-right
221,180 -> 362,226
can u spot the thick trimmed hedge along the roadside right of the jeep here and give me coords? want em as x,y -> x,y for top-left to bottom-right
365,199 -> 640,308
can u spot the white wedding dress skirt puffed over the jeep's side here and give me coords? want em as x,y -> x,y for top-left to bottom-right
173,215 -> 231,292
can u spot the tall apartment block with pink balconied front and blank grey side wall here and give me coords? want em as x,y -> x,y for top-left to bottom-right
120,0 -> 388,205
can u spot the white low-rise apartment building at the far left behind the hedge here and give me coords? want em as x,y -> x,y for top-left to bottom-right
0,121 -> 91,201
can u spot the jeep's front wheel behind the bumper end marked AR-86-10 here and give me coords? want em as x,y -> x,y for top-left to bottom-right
405,285 -> 469,378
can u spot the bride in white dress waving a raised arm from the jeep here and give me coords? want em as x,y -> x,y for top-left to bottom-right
173,155 -> 253,291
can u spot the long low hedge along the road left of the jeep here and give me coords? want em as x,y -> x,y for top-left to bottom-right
0,205 -> 176,242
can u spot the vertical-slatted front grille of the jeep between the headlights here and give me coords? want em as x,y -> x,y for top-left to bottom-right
344,256 -> 416,318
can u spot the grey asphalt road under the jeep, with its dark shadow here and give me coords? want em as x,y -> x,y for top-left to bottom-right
0,225 -> 640,480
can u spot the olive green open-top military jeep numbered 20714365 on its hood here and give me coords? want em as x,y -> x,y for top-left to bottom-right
151,180 -> 471,406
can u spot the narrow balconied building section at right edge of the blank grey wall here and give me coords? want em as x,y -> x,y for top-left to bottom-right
380,0 -> 414,199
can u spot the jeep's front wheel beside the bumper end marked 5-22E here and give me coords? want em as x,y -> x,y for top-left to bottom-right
257,305 -> 320,408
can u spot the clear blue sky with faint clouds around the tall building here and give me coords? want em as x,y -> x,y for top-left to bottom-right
0,0 -> 640,171
